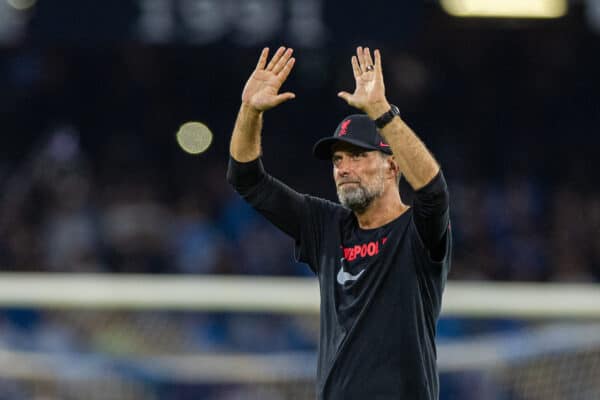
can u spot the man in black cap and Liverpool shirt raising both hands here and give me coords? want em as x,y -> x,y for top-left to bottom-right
228,47 -> 451,400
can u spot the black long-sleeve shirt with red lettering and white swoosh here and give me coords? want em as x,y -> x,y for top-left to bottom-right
227,159 -> 452,400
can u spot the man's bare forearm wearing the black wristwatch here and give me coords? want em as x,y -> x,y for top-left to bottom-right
367,102 -> 440,190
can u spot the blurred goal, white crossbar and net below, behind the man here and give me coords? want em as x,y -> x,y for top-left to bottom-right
0,273 -> 600,400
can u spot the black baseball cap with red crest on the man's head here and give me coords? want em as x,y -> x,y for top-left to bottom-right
313,114 -> 392,160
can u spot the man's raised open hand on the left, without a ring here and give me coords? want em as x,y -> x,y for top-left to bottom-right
242,47 -> 296,112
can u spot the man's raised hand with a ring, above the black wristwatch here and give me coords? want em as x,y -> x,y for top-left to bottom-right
338,47 -> 390,117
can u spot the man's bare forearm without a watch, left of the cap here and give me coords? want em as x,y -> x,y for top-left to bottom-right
229,103 -> 263,162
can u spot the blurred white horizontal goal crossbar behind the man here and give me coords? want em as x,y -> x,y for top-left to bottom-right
0,273 -> 600,319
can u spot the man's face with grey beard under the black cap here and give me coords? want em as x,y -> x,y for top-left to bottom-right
332,142 -> 388,213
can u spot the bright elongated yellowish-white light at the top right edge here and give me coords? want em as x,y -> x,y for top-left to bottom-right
440,0 -> 568,18
